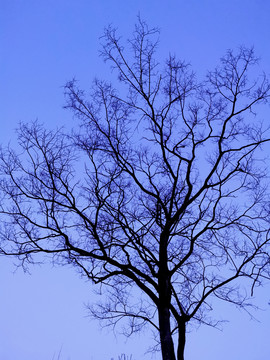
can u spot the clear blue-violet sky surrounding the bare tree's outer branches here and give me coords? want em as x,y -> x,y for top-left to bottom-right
0,0 -> 270,360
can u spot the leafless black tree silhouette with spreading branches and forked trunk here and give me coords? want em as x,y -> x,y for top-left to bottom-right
1,20 -> 270,360
